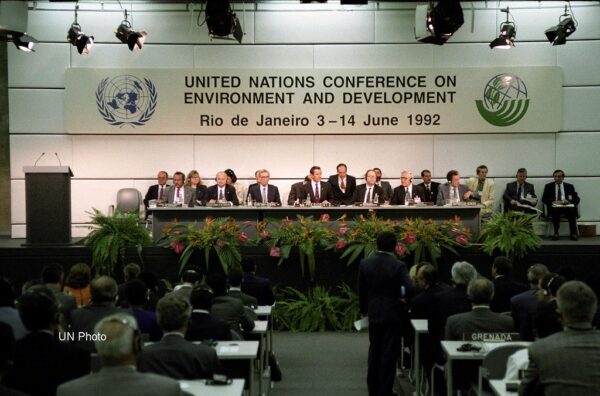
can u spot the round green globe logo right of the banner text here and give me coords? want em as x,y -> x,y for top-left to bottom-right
475,73 -> 529,127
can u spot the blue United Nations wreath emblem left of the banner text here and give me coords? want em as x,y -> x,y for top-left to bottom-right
96,75 -> 158,128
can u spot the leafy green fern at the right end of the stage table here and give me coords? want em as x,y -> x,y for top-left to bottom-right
479,211 -> 541,260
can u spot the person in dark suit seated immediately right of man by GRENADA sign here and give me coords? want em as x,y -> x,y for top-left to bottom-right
510,264 -> 548,341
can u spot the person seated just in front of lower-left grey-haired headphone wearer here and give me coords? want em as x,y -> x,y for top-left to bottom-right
71,276 -> 125,352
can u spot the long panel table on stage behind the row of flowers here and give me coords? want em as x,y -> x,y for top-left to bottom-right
148,205 -> 481,241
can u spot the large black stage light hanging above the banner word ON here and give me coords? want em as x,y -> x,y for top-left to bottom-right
415,0 -> 465,45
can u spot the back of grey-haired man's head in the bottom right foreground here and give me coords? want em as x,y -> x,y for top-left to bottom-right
556,281 -> 598,325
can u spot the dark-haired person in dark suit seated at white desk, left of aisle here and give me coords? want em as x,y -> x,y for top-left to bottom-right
185,287 -> 231,341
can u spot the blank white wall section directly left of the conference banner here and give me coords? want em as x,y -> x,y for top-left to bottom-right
8,89 -> 65,133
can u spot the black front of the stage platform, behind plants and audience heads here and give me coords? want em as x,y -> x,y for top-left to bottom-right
0,236 -> 600,290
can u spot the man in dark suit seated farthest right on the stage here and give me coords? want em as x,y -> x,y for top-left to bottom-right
542,169 -> 579,241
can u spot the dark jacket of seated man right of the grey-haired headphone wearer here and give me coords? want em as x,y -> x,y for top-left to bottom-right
137,334 -> 219,380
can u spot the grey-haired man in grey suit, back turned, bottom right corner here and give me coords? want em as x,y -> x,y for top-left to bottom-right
519,281 -> 600,396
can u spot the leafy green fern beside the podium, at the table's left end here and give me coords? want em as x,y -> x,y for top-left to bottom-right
85,208 -> 152,275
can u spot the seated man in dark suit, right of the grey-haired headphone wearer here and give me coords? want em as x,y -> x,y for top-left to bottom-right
137,295 -> 219,380
